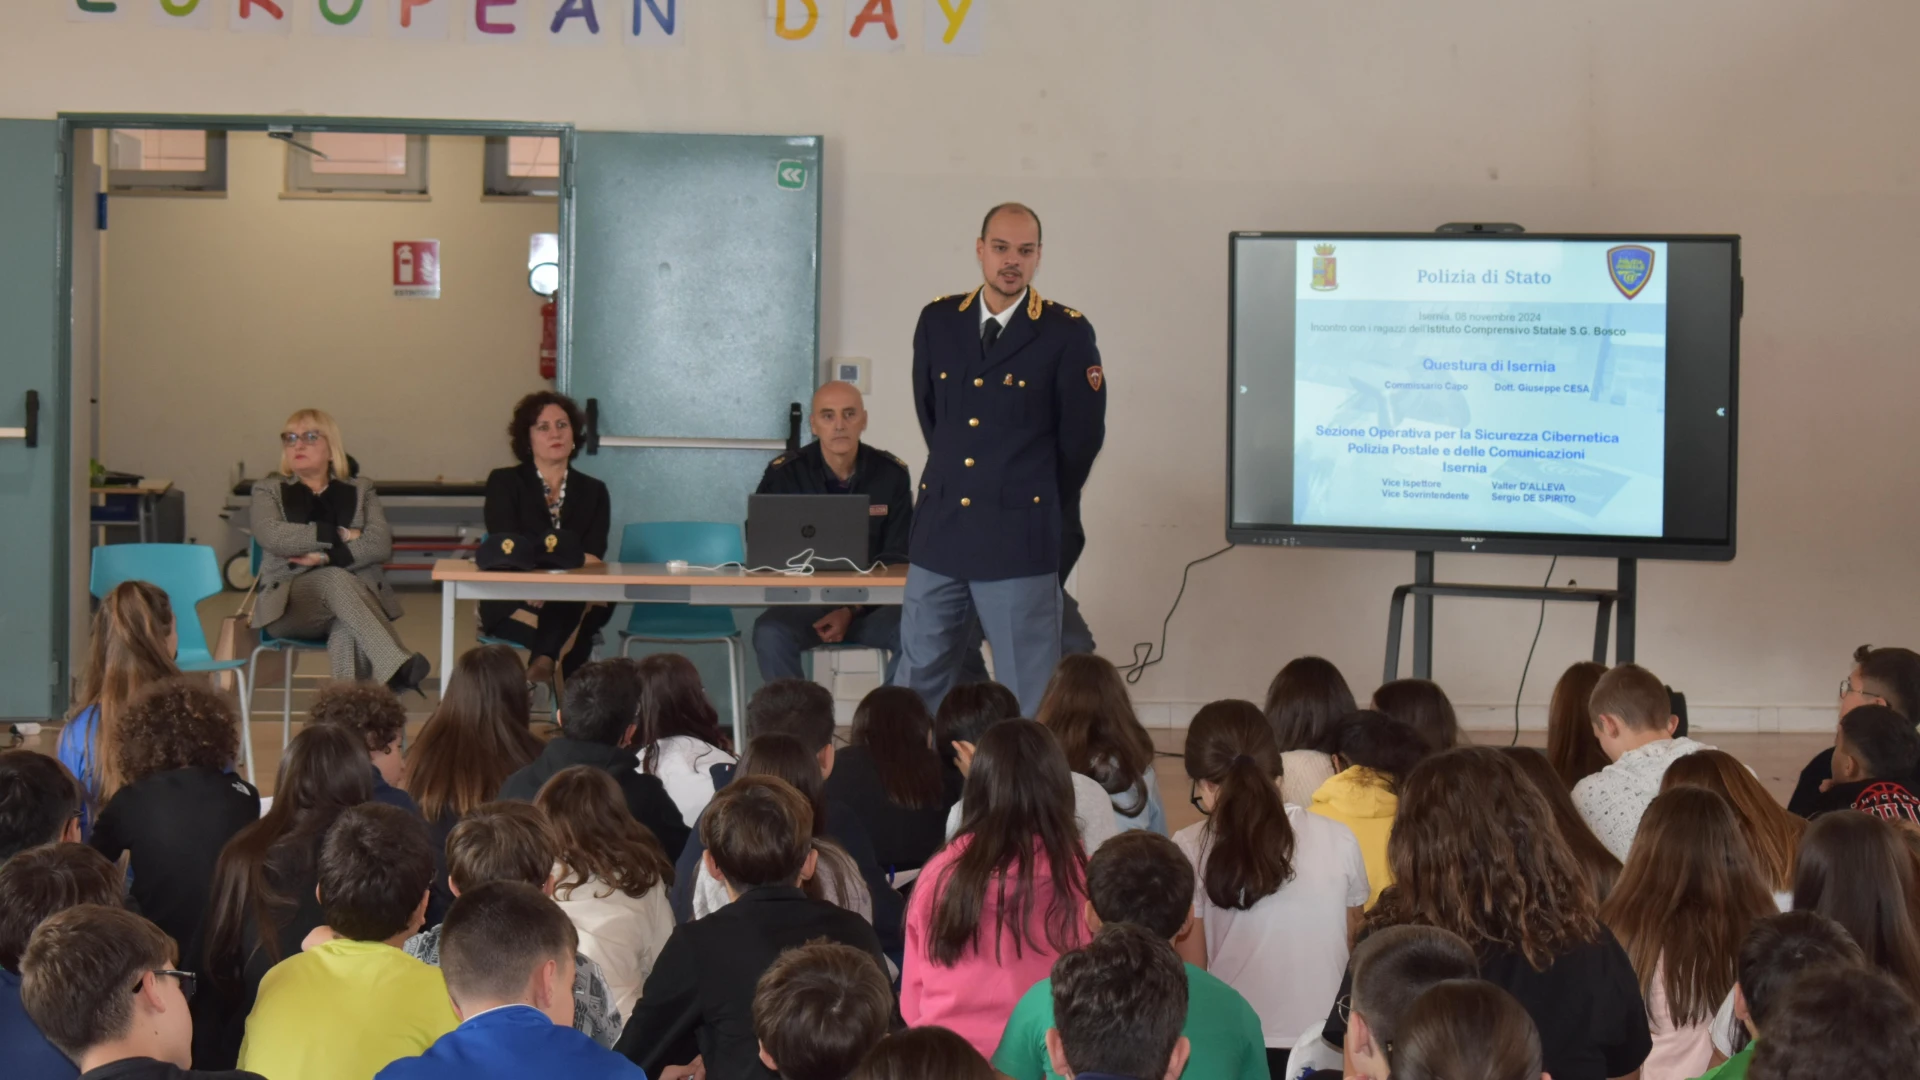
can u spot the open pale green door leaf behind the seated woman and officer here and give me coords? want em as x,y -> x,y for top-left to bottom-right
559,131 -> 822,723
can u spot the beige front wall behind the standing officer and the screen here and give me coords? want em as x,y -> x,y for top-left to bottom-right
0,0 -> 1920,728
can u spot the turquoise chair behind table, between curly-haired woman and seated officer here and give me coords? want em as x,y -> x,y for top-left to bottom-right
620,521 -> 747,734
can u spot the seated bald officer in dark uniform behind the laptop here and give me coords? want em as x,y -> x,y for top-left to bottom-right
753,382 -> 987,682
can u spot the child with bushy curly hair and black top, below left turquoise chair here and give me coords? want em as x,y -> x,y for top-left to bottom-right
92,676 -> 259,963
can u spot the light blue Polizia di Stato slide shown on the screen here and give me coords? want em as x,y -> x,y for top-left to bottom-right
1273,240 -> 1667,536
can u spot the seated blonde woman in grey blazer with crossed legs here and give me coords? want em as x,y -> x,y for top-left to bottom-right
252,409 -> 428,690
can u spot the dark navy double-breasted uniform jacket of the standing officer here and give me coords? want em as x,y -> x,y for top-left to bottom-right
910,288 -> 1106,580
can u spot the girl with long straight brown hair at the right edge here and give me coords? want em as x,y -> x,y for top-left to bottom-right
1793,811 -> 1920,999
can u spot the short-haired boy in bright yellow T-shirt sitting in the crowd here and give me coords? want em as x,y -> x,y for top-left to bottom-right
240,803 -> 459,1080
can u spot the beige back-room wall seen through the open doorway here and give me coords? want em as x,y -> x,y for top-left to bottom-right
100,133 -> 559,557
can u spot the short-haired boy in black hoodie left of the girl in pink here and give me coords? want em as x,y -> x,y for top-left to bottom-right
614,776 -> 883,1080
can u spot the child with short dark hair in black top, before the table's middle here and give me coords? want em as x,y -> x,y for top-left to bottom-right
499,657 -> 687,859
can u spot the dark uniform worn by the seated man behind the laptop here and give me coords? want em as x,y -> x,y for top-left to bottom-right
753,434 -> 985,682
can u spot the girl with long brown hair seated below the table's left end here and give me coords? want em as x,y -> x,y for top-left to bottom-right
407,646 -> 541,907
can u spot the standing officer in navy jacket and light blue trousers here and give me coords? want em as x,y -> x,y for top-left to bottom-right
895,204 -> 1106,717
